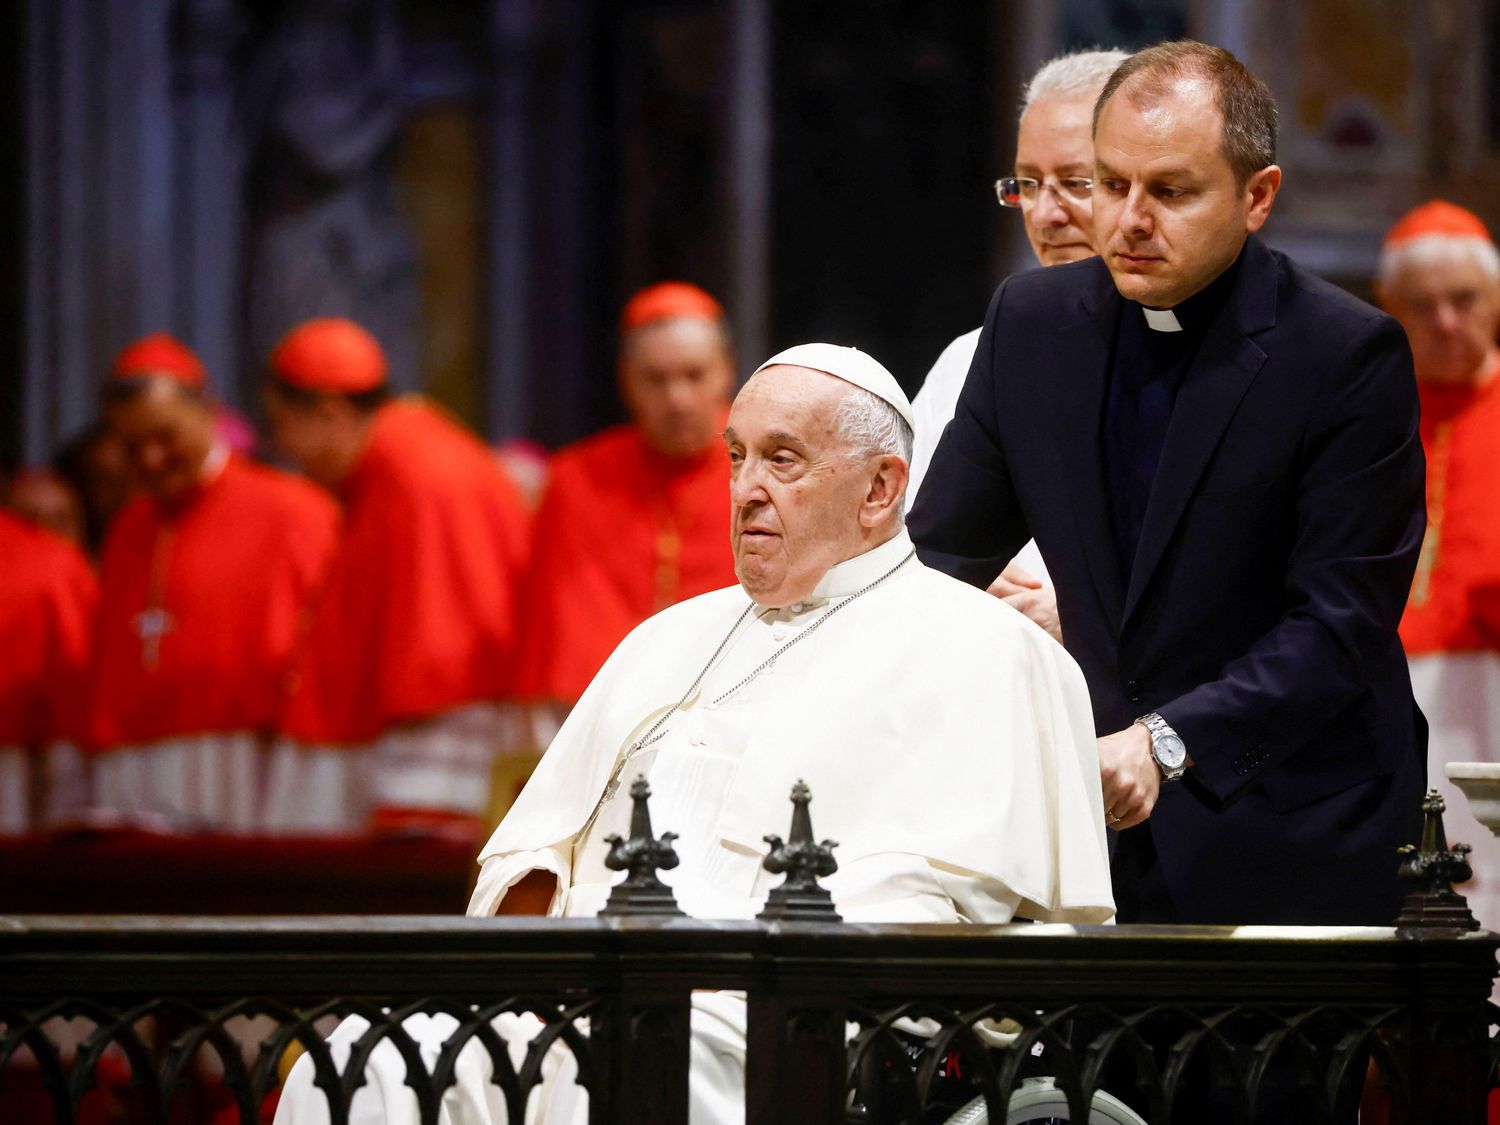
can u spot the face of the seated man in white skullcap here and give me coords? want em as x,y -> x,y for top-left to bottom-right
725,365 -> 879,608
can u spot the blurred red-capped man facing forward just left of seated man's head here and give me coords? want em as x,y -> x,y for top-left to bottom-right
522,282 -> 735,717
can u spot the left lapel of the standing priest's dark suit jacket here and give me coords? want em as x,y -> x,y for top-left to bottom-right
1053,270 -> 1125,629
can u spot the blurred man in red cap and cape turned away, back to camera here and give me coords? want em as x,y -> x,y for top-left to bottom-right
266,318 -> 530,833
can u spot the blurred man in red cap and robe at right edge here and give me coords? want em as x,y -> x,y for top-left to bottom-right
1376,201 -> 1500,929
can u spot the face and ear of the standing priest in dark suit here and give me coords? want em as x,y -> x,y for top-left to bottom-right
1094,77 -> 1281,309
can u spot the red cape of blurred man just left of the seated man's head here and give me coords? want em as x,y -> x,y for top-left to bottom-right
522,426 -> 735,705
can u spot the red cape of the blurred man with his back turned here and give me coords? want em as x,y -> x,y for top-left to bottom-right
284,404 -> 530,746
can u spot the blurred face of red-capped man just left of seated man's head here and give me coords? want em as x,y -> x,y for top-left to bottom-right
620,318 -> 735,458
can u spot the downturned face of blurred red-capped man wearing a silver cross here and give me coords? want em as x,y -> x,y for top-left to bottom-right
105,377 -> 213,504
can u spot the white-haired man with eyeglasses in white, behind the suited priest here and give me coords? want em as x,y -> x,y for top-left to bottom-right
908,51 -> 1127,639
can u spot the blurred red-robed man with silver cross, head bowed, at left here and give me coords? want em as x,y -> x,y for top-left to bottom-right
90,333 -> 338,833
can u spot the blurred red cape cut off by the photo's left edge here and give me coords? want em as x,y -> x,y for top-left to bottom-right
0,512 -> 98,834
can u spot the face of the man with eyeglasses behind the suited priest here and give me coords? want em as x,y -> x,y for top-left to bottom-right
1016,95 -> 1095,266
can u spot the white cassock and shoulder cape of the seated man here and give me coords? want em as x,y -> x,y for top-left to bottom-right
278,531 -> 1115,1125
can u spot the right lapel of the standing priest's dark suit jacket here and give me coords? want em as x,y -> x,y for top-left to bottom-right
1121,236 -> 1277,629
